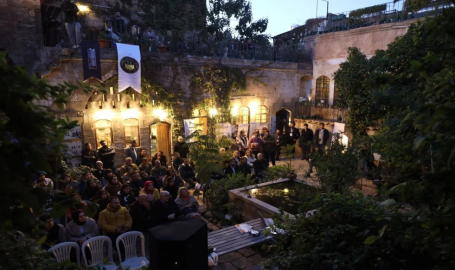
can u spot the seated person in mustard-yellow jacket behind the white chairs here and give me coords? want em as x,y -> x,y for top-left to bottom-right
98,197 -> 133,243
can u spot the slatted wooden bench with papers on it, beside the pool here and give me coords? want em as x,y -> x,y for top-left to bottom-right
208,218 -> 273,255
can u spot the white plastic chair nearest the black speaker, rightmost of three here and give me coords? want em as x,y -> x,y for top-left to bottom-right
116,231 -> 149,270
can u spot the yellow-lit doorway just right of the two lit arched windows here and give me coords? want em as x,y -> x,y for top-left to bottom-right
150,122 -> 171,161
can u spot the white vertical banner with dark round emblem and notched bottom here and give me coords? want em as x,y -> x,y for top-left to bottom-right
117,43 -> 141,93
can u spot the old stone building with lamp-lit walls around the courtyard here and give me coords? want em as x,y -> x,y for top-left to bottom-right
0,0 -> 424,165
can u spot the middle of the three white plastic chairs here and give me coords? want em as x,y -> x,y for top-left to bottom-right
81,236 -> 118,270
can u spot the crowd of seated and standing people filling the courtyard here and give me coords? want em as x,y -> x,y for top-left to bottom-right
36,122 -> 329,252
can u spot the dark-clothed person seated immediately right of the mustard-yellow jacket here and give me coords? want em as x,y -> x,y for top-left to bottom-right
129,194 -> 154,232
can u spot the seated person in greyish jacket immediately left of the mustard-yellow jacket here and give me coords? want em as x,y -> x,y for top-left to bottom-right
65,210 -> 98,245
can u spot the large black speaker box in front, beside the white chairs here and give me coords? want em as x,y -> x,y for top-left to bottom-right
149,218 -> 208,270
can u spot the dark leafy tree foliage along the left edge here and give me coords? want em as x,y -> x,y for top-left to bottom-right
0,55 -> 86,269
